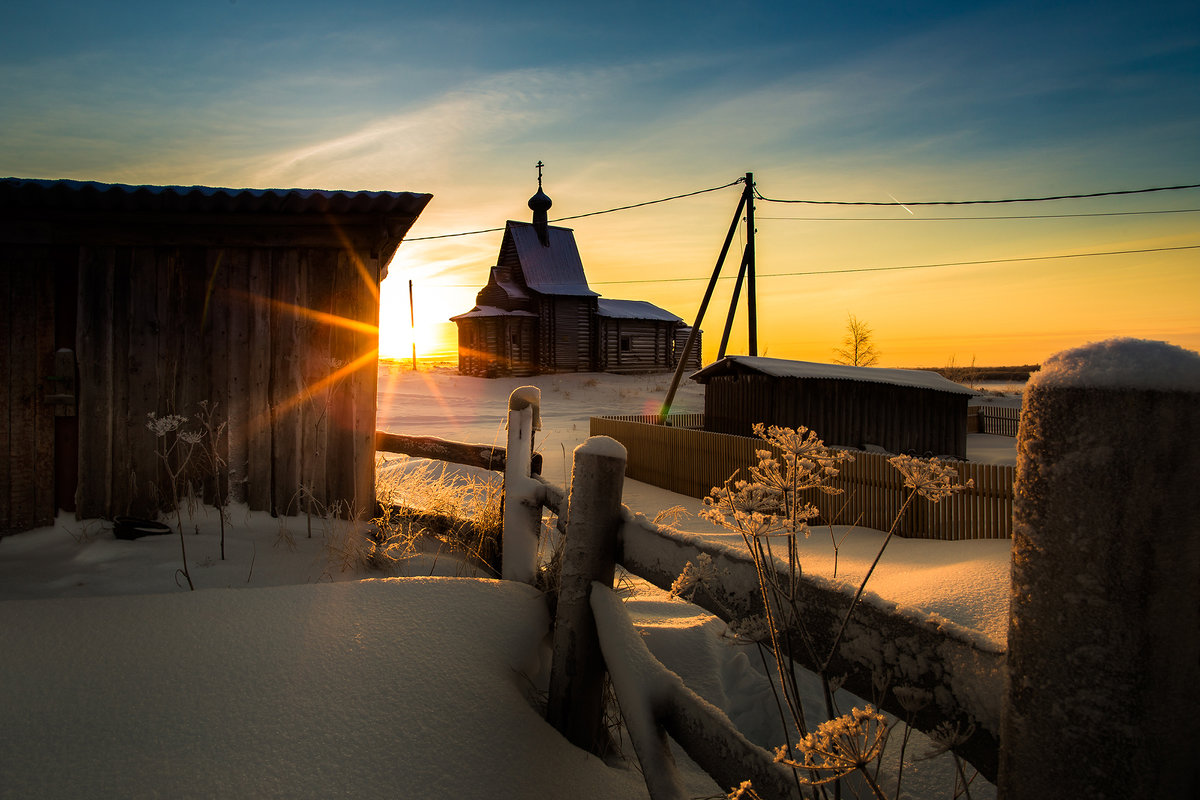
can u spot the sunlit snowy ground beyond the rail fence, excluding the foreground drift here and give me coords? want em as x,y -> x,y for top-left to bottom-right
379,365 -> 1019,646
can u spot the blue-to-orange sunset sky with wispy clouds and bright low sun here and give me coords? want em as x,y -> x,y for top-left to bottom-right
0,0 -> 1200,366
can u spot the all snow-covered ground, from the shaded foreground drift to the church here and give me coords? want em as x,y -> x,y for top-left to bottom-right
0,365 -> 1013,799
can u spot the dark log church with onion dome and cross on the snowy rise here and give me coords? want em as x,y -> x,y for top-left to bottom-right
450,175 -> 701,378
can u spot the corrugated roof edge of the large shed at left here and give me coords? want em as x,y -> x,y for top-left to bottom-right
0,178 -> 433,218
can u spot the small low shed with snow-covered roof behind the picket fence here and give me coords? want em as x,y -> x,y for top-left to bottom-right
692,356 -> 973,458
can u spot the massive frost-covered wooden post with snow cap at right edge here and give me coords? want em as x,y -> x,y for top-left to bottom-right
998,339 -> 1200,800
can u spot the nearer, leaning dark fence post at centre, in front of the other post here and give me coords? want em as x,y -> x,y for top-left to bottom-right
546,437 -> 625,753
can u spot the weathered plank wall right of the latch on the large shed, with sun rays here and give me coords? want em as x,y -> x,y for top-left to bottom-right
77,246 -> 378,525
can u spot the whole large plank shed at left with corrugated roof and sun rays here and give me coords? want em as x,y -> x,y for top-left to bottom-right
0,179 -> 431,533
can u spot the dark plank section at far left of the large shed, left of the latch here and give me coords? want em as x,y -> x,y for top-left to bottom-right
0,247 -> 56,534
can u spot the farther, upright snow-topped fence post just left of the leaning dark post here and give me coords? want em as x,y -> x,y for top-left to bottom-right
500,386 -> 541,583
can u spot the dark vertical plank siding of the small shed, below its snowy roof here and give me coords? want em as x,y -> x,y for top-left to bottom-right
704,374 -> 968,458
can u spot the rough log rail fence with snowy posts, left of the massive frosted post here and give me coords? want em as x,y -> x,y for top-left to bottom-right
391,387 -> 1004,800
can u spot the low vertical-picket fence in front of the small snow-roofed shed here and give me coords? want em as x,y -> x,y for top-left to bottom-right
590,414 -> 1015,540
